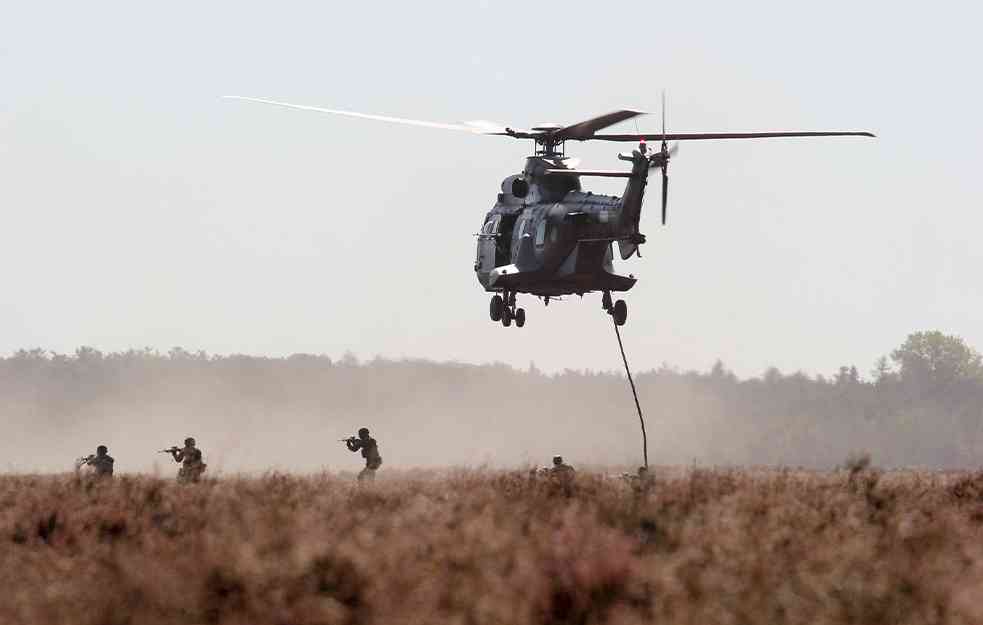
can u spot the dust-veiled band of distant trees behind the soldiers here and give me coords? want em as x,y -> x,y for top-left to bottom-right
0,332 -> 983,471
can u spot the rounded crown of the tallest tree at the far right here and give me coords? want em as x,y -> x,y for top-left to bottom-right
891,330 -> 983,390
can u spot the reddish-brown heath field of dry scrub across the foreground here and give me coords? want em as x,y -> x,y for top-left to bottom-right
0,469 -> 983,625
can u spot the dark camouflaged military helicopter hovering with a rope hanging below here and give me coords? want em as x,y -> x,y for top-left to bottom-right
225,94 -> 874,328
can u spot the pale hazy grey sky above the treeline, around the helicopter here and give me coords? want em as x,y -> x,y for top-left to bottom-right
0,0 -> 983,375
